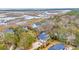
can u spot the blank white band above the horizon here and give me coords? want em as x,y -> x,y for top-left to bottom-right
0,0 -> 79,8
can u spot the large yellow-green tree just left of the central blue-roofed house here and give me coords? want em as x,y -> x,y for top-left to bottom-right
19,33 -> 36,49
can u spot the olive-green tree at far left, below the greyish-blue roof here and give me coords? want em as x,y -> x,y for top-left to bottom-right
4,33 -> 17,49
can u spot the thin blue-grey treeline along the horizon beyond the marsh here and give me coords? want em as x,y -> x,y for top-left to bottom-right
0,8 -> 79,11
